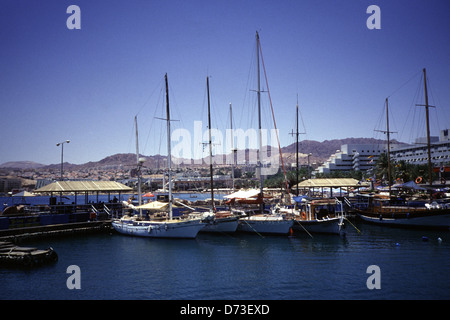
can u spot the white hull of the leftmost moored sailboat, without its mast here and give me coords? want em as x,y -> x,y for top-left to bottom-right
112,220 -> 205,239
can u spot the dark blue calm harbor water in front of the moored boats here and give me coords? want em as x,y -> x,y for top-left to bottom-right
0,223 -> 450,300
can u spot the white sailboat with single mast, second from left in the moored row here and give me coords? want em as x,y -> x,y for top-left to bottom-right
190,77 -> 239,233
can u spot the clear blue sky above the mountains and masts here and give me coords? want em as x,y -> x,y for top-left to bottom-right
0,0 -> 450,164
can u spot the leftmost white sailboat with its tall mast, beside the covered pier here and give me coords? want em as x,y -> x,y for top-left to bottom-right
112,74 -> 205,238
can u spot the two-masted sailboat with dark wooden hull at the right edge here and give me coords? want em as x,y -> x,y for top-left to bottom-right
355,69 -> 450,230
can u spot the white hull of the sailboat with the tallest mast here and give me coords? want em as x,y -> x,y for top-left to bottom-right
238,216 -> 294,235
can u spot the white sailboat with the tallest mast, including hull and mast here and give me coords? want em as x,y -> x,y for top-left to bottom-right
230,32 -> 294,235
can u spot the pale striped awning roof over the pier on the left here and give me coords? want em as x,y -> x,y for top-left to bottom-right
34,181 -> 133,193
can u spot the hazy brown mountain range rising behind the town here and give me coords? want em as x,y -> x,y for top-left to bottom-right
0,138 -> 394,170
